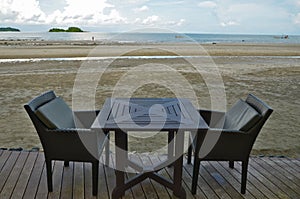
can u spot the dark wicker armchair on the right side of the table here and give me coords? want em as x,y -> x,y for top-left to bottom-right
188,94 -> 273,194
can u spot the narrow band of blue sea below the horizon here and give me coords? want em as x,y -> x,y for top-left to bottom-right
0,32 -> 300,44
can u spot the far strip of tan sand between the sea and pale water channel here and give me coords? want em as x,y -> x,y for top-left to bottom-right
0,40 -> 300,59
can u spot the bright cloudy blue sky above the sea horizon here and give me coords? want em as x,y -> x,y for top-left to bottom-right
0,0 -> 300,35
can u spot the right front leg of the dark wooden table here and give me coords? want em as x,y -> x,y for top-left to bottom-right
173,131 -> 186,199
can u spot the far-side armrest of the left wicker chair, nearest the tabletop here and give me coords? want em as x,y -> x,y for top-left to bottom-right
73,110 -> 100,128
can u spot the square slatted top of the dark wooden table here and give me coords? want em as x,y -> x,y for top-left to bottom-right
91,98 -> 208,131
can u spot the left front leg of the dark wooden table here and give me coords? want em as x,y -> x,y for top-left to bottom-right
112,131 -> 128,199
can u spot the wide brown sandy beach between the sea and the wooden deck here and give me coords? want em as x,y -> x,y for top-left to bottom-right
0,41 -> 300,158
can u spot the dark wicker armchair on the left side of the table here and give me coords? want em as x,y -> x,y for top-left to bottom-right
24,91 -> 109,195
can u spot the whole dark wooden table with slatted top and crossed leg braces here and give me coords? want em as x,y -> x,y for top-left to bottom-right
92,98 -> 208,199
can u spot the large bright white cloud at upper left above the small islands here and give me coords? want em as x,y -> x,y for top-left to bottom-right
0,0 -> 127,26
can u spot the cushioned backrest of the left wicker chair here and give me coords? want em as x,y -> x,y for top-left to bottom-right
24,91 -> 75,129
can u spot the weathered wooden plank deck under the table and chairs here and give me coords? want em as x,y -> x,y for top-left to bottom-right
0,150 -> 300,199
